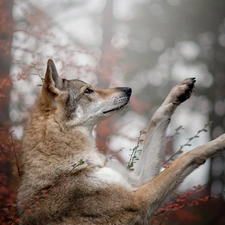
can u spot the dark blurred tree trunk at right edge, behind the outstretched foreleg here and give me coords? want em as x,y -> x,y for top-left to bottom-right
207,44 -> 225,194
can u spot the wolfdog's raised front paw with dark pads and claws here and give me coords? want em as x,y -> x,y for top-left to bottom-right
171,78 -> 196,105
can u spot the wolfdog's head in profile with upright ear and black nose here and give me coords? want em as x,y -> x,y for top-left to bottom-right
42,59 -> 132,126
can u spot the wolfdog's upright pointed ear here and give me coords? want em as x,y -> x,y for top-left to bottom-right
43,59 -> 62,95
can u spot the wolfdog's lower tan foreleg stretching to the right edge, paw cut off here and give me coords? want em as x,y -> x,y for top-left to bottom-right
134,134 -> 225,221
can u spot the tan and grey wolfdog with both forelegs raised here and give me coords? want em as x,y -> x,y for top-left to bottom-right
18,60 -> 225,225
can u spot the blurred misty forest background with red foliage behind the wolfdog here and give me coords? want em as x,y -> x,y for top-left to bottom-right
0,0 -> 225,225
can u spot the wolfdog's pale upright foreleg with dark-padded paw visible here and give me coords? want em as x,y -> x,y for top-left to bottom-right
134,78 -> 195,185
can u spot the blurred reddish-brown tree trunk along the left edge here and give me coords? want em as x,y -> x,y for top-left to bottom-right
0,0 -> 16,224
